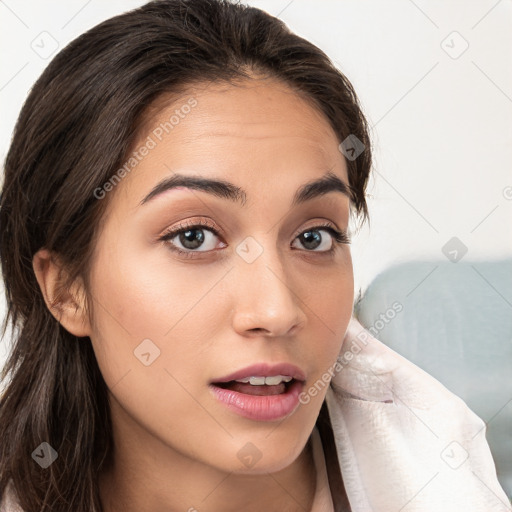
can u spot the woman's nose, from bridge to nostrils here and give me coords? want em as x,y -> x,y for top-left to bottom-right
231,243 -> 307,337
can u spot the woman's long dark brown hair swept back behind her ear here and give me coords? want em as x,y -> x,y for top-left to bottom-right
0,0 -> 371,512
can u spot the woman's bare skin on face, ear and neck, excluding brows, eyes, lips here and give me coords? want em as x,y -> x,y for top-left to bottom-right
33,78 -> 354,512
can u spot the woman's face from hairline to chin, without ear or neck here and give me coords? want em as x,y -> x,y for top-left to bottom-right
86,79 -> 353,473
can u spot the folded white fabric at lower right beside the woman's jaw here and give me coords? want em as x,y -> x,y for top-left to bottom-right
326,318 -> 512,512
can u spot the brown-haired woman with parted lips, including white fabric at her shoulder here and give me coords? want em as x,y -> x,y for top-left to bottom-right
0,0 -> 507,512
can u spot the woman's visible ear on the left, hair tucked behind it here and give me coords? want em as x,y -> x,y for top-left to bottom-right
32,249 -> 91,337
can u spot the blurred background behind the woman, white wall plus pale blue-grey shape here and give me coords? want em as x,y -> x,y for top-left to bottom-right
0,0 -> 512,504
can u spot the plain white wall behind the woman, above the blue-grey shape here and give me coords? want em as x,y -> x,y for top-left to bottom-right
0,0 -> 512,364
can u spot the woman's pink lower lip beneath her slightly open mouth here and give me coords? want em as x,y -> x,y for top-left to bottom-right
209,380 -> 304,421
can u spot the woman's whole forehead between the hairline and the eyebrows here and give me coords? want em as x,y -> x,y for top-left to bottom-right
107,78 -> 348,210
